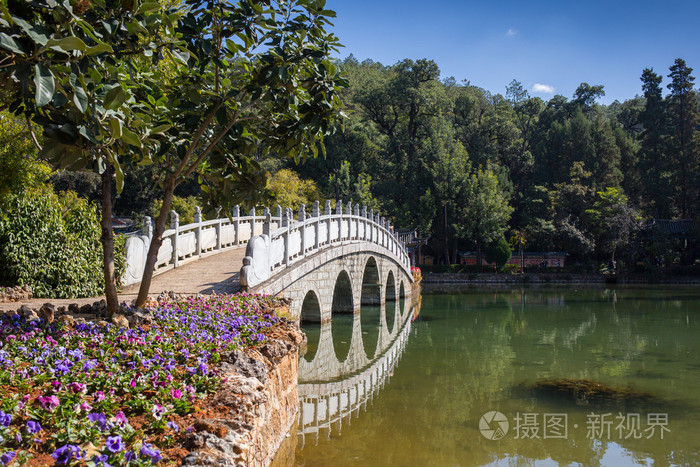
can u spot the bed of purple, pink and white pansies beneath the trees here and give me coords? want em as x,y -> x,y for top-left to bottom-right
0,294 -> 278,465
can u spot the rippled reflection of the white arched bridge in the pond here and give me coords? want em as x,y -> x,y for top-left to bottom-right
297,294 -> 416,449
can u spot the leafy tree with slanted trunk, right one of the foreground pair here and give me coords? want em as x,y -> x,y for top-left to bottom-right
136,0 -> 346,306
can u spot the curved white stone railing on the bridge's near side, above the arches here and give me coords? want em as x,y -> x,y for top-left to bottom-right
240,201 -> 411,287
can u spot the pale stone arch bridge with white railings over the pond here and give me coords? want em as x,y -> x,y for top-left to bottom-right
124,201 -> 413,321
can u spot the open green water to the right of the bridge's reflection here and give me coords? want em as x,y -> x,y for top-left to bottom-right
294,289 -> 700,465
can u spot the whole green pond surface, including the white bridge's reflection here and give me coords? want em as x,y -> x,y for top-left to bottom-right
284,286 -> 700,466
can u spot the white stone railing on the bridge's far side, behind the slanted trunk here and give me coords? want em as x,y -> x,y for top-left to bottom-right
122,206 -> 282,285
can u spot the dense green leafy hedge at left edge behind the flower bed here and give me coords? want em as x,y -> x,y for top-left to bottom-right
0,189 -> 125,298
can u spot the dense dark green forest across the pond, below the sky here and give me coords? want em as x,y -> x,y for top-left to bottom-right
272,56 -> 700,264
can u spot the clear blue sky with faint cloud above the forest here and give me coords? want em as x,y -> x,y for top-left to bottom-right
326,0 -> 700,104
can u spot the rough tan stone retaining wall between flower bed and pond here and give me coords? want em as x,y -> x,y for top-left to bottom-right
182,323 -> 305,467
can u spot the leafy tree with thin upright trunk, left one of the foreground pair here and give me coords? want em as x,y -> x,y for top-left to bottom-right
0,0 -> 183,312
